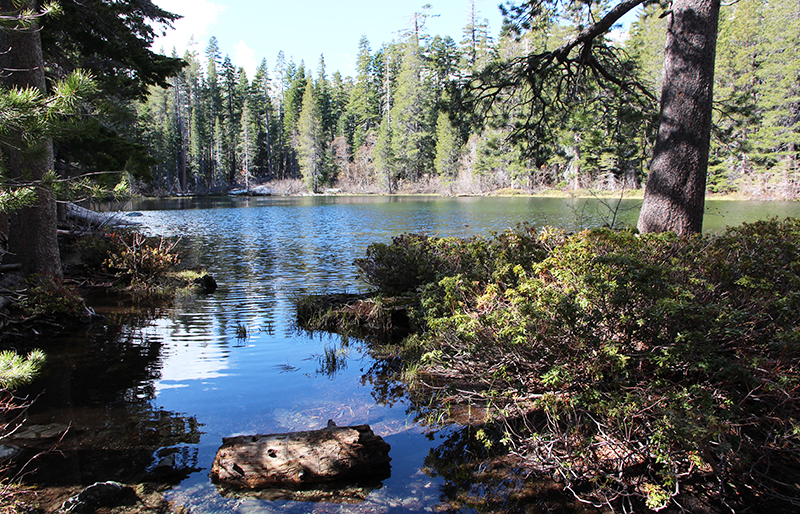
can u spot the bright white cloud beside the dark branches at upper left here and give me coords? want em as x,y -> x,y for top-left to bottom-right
152,0 -> 227,56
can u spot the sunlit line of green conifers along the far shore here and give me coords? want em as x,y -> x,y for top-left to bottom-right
138,0 -> 800,198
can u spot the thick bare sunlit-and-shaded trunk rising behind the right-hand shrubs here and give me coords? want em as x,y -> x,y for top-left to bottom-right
638,0 -> 720,235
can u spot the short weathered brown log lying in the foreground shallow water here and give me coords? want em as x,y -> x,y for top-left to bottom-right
210,422 -> 391,489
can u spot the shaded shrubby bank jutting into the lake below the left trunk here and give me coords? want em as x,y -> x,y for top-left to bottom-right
0,214 -> 209,343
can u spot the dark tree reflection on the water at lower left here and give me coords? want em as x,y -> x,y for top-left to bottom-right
16,318 -> 202,487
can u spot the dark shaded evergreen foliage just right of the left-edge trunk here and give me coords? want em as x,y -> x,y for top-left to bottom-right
39,0 -> 184,186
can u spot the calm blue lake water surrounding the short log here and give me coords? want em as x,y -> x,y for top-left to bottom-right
18,197 -> 800,513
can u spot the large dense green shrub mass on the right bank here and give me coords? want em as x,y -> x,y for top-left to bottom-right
298,215 -> 800,512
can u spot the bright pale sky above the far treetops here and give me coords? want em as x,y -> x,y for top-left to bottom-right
153,0 -> 502,79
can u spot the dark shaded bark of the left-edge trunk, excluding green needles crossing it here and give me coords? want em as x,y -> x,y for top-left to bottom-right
0,0 -> 62,277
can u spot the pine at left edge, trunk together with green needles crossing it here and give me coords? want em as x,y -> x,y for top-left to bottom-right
0,0 -> 91,277
